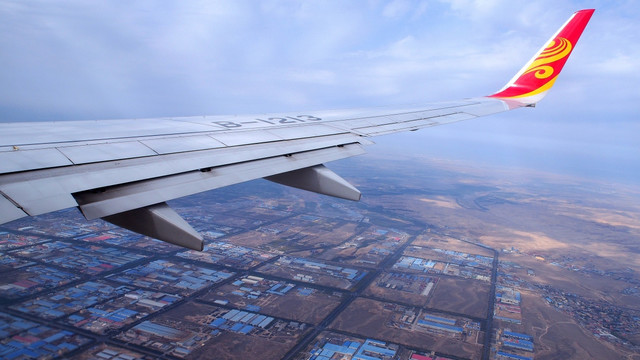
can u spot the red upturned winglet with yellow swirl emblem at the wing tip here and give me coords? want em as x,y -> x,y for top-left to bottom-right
488,9 -> 595,105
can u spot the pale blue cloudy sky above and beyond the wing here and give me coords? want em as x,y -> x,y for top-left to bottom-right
0,0 -> 640,184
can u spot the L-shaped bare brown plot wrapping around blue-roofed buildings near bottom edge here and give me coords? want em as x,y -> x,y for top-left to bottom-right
330,298 -> 482,359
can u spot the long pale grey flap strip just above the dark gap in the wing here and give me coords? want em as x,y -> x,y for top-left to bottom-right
0,134 -> 369,215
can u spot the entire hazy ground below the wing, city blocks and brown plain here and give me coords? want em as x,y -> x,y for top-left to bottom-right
0,155 -> 640,360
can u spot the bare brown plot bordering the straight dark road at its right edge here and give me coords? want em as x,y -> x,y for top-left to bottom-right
427,276 -> 489,318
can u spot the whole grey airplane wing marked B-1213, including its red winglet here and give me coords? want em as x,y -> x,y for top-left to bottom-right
0,9 -> 594,250
